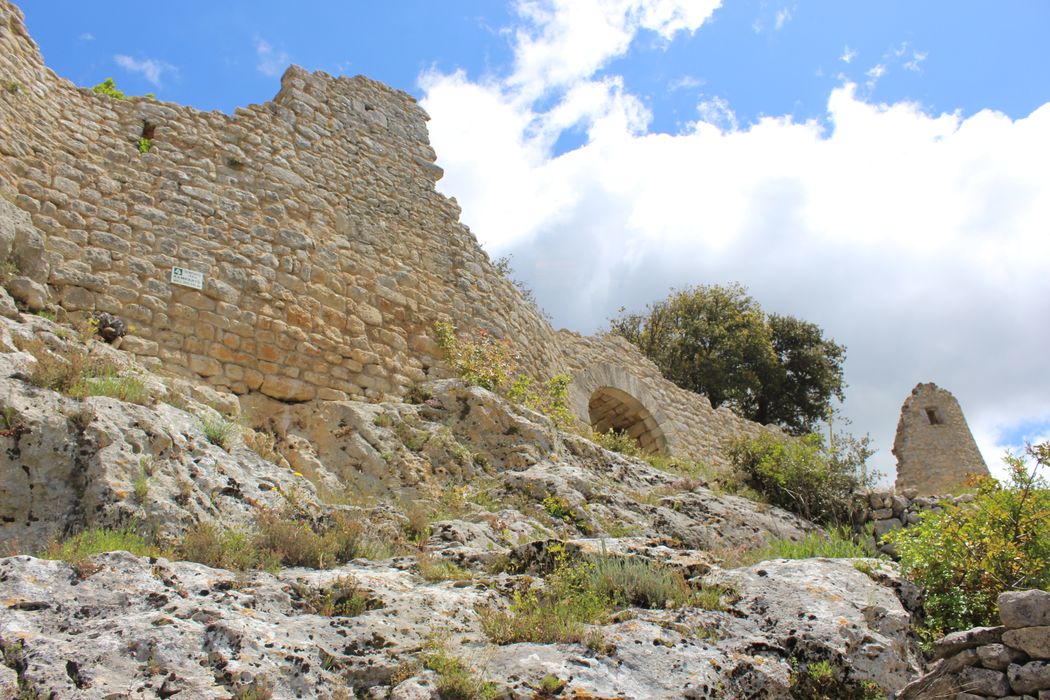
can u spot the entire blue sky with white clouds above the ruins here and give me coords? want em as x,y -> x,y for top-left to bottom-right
14,0 -> 1050,473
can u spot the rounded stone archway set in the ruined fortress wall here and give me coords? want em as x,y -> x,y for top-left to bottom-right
570,363 -> 677,454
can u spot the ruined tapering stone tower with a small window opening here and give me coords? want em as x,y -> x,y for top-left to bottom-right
894,383 -> 988,495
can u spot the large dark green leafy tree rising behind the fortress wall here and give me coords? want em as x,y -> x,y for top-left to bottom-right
610,283 -> 845,434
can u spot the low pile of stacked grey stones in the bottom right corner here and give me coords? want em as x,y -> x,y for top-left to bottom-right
899,591 -> 1050,700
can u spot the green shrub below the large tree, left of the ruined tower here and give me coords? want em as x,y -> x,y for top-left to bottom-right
728,432 -> 877,525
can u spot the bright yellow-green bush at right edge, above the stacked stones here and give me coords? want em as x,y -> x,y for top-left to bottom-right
883,443 -> 1050,641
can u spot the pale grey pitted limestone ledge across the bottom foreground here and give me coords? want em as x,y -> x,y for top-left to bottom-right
0,552 -> 918,700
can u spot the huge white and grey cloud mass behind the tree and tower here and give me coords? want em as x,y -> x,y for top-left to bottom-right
421,0 -> 1050,476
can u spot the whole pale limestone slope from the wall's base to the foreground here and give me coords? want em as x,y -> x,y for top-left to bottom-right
0,306 -> 921,699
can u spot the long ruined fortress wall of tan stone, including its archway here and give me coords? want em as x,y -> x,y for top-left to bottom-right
0,0 -> 761,464
